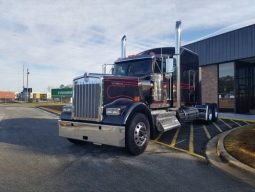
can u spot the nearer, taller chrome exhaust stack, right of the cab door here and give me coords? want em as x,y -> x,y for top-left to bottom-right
175,21 -> 181,108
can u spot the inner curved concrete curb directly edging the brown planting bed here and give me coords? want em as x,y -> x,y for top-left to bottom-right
217,127 -> 255,176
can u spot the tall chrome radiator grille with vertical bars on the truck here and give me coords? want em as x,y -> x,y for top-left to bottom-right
73,77 -> 102,121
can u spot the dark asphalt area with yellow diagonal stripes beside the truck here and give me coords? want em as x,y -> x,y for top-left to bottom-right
152,119 -> 251,159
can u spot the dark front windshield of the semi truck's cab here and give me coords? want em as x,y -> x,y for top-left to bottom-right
114,59 -> 152,77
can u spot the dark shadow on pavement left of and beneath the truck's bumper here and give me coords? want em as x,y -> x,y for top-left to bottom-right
0,118 -> 130,158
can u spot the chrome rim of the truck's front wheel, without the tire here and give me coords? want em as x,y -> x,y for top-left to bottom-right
134,122 -> 147,147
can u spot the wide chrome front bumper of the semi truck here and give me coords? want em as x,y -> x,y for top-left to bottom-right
58,120 -> 125,147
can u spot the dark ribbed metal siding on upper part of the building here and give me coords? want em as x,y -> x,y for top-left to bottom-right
184,25 -> 255,65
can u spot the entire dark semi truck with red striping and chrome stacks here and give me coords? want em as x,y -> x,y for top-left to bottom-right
59,21 -> 218,155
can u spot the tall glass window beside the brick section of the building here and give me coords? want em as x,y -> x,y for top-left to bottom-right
218,62 -> 235,111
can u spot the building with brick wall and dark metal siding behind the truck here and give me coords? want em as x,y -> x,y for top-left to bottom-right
184,24 -> 255,113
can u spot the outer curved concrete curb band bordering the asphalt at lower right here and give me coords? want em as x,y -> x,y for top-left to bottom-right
205,127 -> 255,187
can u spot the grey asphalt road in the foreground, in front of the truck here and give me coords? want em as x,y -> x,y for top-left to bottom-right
0,106 -> 255,192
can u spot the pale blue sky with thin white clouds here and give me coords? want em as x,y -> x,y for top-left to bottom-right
0,0 -> 255,92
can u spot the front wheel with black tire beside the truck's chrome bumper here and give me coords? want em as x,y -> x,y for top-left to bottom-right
126,113 -> 150,155
